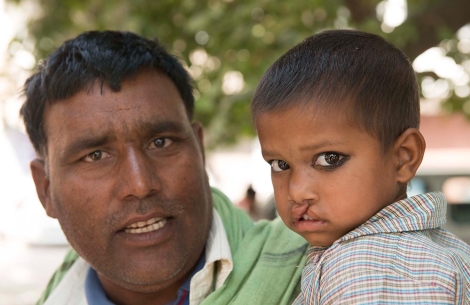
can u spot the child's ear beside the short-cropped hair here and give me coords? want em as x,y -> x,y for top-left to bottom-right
394,128 -> 426,183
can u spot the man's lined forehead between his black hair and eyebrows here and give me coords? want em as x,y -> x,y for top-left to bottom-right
44,72 -> 191,146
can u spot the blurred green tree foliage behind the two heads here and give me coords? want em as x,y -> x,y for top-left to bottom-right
9,0 -> 470,147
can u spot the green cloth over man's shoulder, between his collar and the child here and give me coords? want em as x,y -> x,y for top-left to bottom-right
203,204 -> 308,305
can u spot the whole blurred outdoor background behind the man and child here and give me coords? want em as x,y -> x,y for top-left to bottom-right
0,0 -> 470,305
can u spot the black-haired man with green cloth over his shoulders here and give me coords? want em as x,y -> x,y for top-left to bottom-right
21,31 -> 306,305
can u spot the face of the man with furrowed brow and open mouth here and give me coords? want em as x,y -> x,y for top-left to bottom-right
35,71 -> 212,292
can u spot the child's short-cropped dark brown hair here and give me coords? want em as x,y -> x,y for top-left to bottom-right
251,30 -> 419,152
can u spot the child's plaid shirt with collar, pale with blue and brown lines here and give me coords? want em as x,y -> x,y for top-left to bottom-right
294,193 -> 470,305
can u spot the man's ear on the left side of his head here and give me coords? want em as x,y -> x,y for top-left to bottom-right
29,159 -> 57,218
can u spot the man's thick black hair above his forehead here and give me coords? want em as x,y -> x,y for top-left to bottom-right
20,31 -> 194,157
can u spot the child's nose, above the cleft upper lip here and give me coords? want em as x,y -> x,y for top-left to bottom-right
288,169 -> 318,204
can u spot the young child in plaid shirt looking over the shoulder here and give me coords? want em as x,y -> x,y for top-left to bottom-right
251,30 -> 470,305
